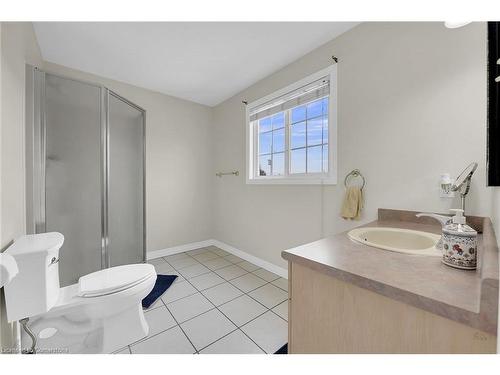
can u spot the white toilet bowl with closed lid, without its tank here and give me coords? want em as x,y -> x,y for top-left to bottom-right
30,264 -> 156,353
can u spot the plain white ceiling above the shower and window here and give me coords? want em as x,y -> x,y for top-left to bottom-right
34,22 -> 357,106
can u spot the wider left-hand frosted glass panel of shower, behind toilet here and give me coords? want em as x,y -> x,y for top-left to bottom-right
44,73 -> 102,286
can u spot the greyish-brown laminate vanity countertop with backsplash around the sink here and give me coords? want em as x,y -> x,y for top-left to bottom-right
282,209 -> 499,335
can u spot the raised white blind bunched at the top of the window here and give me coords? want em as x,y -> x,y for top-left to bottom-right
250,76 -> 330,121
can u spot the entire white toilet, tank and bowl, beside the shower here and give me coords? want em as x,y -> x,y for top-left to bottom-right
4,232 -> 156,353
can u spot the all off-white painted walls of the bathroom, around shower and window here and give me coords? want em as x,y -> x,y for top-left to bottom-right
0,23 -> 500,345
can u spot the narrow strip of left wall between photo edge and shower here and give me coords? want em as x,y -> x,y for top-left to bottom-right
0,22 -> 41,347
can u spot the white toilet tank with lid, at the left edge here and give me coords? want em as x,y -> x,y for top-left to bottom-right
4,232 -> 64,322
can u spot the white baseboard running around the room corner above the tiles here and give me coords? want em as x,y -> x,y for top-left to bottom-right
147,239 -> 288,279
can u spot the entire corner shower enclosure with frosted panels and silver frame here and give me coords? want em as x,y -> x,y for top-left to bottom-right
26,66 -> 146,286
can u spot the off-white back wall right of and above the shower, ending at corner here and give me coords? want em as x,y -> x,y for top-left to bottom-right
42,62 -> 213,251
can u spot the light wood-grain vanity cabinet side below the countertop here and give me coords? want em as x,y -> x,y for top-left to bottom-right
288,261 -> 497,354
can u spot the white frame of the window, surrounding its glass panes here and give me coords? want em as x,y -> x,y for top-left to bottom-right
245,64 -> 338,185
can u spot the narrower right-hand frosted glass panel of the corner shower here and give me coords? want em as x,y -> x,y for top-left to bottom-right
107,91 -> 144,267
